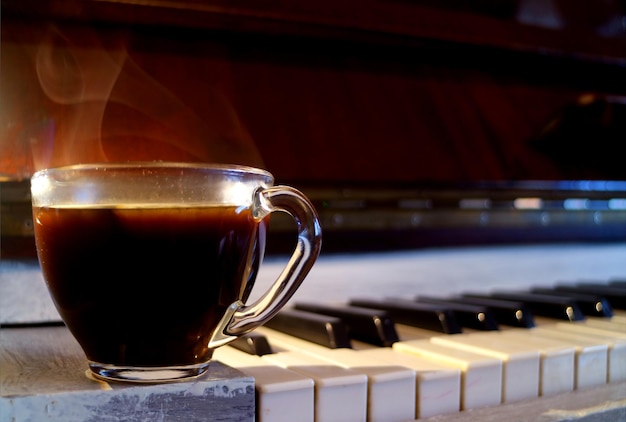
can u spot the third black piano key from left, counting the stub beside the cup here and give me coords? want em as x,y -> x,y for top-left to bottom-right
294,302 -> 399,347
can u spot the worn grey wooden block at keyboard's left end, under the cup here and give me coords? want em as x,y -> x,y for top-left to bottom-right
0,327 -> 254,422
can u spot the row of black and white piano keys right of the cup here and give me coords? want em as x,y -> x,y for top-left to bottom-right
214,280 -> 626,422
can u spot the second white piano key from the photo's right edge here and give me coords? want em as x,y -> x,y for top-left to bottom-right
503,327 -> 608,389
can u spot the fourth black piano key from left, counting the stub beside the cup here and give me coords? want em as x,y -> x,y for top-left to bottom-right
350,299 -> 462,334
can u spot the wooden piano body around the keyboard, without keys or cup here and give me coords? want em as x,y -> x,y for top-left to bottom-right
0,0 -> 626,421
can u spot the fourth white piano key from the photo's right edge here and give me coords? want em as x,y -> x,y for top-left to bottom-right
430,333 -> 540,402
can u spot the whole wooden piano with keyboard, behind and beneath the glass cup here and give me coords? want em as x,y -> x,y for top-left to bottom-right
0,0 -> 626,422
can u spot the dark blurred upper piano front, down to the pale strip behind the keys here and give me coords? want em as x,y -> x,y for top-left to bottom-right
0,0 -> 626,253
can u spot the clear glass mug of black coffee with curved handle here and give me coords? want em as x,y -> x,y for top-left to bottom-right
31,162 -> 321,382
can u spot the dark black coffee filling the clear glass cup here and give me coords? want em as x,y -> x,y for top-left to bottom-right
33,206 -> 266,366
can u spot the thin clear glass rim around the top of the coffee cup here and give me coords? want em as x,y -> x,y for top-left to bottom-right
32,161 -> 274,180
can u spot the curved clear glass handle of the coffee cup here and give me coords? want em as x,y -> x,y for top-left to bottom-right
208,186 -> 322,348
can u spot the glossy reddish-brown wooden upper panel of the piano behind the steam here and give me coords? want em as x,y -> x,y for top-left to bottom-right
0,0 -> 626,184
